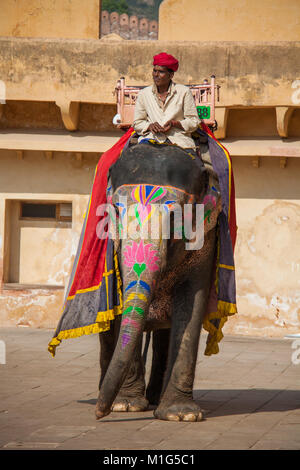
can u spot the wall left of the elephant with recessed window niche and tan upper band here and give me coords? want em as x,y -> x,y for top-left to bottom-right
0,150 -> 99,328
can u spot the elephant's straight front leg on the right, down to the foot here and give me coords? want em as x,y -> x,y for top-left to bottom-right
154,233 -> 214,421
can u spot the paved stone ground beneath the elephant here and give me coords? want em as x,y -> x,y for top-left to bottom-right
0,328 -> 300,450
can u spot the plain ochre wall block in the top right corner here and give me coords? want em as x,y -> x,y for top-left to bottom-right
158,0 -> 300,41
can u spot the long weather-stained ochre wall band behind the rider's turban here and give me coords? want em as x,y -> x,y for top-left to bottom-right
0,37 -> 300,106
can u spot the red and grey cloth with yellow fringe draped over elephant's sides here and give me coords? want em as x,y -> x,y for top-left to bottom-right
48,124 -> 237,356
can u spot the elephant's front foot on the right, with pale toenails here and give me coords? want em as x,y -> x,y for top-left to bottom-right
154,399 -> 203,422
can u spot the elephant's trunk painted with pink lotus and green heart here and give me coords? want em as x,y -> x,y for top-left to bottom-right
96,239 -> 162,419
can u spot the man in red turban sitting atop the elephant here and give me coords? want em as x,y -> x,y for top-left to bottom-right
133,52 -> 200,150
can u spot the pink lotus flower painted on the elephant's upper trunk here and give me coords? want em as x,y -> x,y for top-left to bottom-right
124,240 -> 159,272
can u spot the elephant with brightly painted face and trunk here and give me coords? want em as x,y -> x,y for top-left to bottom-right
95,143 -> 221,421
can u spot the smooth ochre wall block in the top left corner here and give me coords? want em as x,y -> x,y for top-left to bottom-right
0,0 -> 100,39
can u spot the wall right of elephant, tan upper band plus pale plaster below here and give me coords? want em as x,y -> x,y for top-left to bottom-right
225,157 -> 300,337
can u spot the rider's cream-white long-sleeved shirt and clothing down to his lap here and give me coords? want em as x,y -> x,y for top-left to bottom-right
133,82 -> 200,148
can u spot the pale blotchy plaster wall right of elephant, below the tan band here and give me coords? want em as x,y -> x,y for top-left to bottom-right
226,200 -> 300,336
